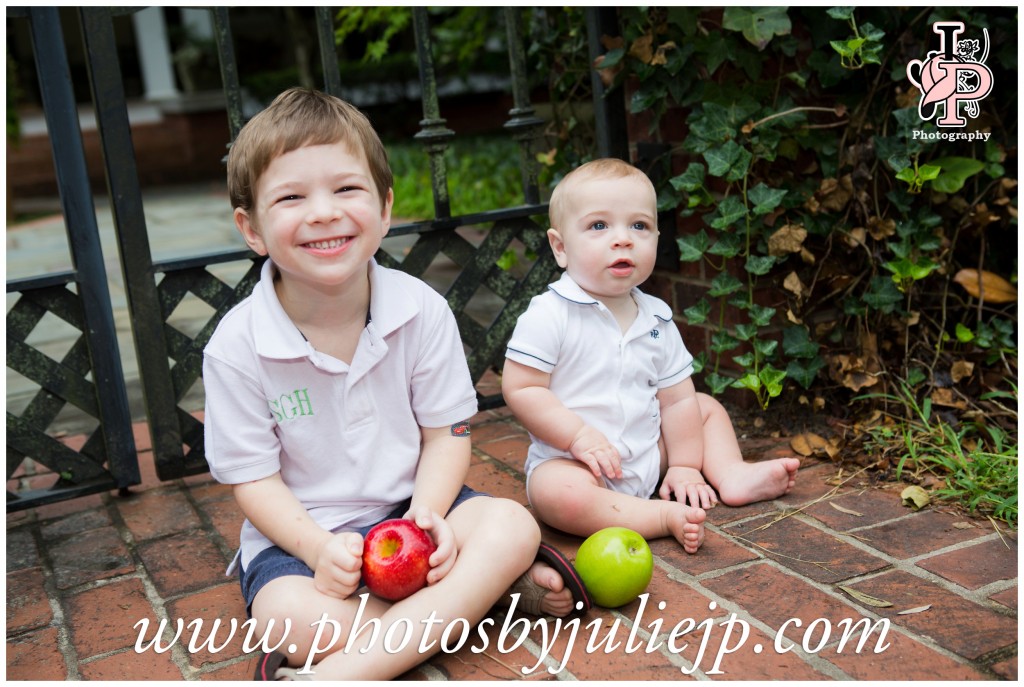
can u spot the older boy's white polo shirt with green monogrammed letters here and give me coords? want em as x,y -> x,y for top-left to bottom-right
203,260 -> 477,566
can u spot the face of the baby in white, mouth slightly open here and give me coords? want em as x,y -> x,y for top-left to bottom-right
549,176 -> 657,300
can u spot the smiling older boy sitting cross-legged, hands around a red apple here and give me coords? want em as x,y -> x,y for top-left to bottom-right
204,89 -> 578,680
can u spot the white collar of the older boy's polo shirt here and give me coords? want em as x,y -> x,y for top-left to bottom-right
253,258 -> 420,359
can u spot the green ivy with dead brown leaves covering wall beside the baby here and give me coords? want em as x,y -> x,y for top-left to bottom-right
549,7 -> 1017,415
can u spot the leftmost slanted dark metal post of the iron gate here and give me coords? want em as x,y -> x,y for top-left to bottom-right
30,7 -> 141,488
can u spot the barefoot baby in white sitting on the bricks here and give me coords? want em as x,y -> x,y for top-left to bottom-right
502,160 -> 800,553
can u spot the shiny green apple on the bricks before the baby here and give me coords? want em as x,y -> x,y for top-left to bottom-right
574,527 -> 654,608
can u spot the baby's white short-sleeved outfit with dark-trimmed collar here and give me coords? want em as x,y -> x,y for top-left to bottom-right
505,272 -> 693,499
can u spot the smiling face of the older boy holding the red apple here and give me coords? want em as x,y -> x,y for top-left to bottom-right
234,142 -> 393,293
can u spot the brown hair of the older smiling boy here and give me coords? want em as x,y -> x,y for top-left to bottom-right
227,88 -> 392,212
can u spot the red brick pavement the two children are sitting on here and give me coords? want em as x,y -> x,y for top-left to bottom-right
6,411 -> 1018,681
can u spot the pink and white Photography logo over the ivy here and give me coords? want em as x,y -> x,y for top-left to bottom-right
906,22 -> 992,140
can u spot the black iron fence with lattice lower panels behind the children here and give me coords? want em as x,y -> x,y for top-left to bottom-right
7,7 -> 627,511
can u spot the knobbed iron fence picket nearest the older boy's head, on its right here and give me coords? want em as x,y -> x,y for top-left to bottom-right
413,7 -> 455,219
